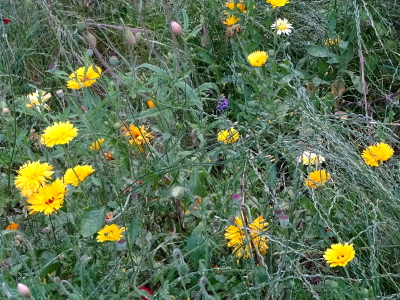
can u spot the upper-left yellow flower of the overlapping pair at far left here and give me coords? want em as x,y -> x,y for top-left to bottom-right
14,161 -> 54,197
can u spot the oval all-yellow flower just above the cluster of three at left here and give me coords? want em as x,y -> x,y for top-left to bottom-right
40,122 -> 78,148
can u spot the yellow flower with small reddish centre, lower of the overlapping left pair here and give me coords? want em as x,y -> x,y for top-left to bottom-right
28,179 -> 66,215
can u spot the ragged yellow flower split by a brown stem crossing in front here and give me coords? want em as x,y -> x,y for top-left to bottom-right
225,216 -> 268,258
